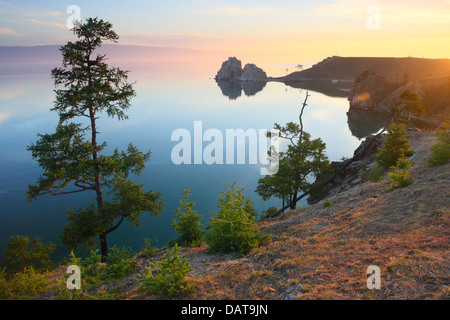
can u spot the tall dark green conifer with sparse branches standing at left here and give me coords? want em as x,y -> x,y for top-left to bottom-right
28,18 -> 164,260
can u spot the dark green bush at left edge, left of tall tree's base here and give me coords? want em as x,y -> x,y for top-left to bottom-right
3,236 -> 56,274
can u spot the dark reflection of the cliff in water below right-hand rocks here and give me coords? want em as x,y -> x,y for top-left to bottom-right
347,109 -> 391,139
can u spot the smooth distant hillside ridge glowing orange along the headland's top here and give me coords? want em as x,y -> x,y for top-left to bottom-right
279,56 -> 450,82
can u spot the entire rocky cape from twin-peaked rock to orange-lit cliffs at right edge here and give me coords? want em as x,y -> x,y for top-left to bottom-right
215,56 -> 450,126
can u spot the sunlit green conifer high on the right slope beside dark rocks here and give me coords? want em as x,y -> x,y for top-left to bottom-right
375,121 -> 414,169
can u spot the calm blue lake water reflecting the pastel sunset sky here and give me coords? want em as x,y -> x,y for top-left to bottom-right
0,57 -> 377,255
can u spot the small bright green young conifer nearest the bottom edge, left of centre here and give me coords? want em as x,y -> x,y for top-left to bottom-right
141,244 -> 194,297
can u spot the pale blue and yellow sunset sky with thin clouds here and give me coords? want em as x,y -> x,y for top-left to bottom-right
0,0 -> 450,63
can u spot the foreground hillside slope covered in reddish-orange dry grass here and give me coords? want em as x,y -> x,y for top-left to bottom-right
36,131 -> 450,300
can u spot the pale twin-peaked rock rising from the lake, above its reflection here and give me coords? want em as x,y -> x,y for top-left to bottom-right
215,57 -> 267,81
